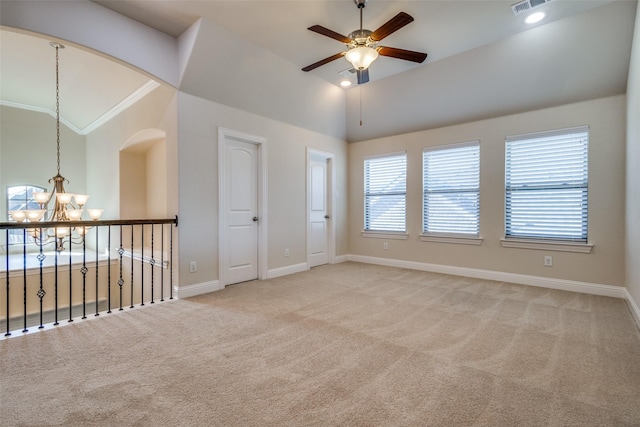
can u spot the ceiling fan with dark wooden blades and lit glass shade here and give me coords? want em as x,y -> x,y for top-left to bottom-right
302,0 -> 427,84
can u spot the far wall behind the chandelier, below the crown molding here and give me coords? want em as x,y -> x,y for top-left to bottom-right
0,106 -> 86,221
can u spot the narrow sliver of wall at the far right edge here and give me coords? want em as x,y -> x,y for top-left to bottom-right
625,8 -> 640,310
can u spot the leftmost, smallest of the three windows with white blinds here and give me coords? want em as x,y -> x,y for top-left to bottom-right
364,153 -> 407,232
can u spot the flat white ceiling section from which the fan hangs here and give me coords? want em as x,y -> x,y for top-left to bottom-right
94,0 -> 614,84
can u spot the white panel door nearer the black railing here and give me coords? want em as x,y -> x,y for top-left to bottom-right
224,140 -> 259,284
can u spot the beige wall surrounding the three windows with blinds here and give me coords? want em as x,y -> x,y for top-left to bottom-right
349,96 -> 626,286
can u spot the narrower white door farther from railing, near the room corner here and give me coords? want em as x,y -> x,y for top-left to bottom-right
308,154 -> 330,267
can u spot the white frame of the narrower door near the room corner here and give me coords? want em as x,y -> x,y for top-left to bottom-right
305,147 -> 336,268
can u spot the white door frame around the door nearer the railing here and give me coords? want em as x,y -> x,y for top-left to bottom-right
218,127 -> 269,288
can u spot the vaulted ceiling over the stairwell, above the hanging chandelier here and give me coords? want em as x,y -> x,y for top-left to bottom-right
0,30 -> 158,135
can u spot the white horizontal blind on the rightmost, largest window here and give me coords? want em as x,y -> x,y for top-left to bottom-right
505,126 -> 589,243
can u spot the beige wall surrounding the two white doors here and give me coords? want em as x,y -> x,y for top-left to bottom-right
178,92 -> 347,286
